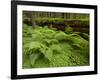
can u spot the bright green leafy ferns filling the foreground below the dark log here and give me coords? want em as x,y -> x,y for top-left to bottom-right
23,25 -> 89,68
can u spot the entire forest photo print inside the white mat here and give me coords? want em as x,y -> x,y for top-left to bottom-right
23,11 -> 89,68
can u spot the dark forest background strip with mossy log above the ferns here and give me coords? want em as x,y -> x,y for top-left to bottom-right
23,11 -> 89,33
